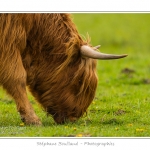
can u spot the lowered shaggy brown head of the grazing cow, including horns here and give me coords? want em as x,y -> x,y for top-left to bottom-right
26,41 -> 127,123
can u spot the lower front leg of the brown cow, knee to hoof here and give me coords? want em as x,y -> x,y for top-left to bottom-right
5,81 -> 41,125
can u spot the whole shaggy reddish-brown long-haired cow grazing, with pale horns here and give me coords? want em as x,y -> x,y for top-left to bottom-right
0,14 -> 126,125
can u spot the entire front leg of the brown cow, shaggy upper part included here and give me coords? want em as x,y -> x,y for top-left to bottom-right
2,55 -> 41,125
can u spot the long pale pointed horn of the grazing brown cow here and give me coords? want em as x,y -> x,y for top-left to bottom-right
80,45 -> 128,60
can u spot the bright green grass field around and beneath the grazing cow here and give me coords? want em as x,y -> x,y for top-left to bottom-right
0,13 -> 150,137
